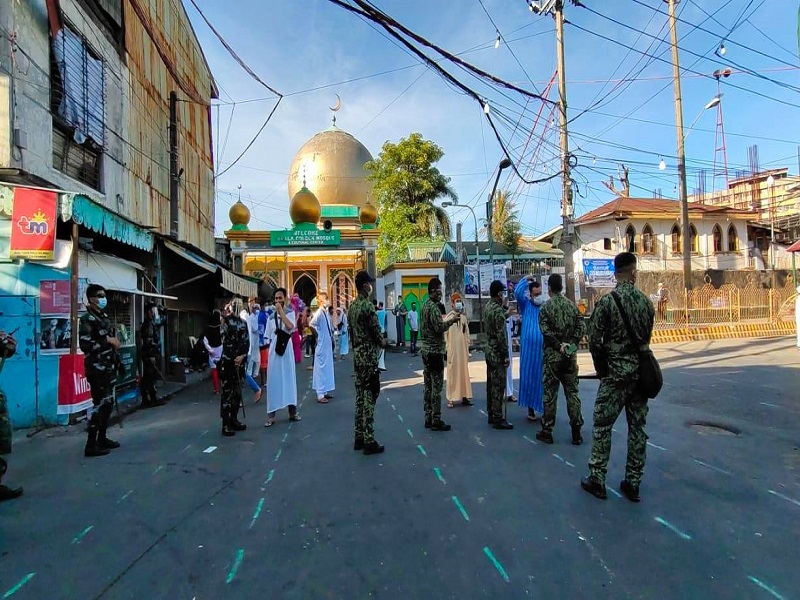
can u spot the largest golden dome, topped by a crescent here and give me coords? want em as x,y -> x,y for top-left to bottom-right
289,126 -> 372,206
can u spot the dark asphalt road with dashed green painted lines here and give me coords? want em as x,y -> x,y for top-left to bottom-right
0,339 -> 800,600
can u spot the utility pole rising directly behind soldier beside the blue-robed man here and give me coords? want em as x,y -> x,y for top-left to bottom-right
553,0 -> 576,302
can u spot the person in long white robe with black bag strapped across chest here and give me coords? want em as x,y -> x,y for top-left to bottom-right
264,288 -> 300,427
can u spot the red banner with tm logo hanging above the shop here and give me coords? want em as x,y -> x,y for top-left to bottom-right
10,188 -> 57,260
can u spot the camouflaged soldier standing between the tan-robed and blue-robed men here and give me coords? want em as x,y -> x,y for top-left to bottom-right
483,280 -> 514,429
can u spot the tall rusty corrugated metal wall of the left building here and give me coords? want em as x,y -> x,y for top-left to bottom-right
124,0 -> 216,256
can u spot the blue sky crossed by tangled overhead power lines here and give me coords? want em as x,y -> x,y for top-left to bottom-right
186,0 -> 800,239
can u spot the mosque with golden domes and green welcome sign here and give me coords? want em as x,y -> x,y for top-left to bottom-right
225,117 -> 379,307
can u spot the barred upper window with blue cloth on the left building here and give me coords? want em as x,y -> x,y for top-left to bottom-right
50,25 -> 106,189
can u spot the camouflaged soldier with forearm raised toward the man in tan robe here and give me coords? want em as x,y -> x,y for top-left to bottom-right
419,277 -> 459,431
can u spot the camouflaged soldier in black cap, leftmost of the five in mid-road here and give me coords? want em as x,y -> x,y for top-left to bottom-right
347,271 -> 386,455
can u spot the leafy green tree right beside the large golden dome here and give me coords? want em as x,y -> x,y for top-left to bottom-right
365,133 -> 457,268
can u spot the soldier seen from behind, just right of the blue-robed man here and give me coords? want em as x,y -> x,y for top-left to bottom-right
536,273 -> 583,446
